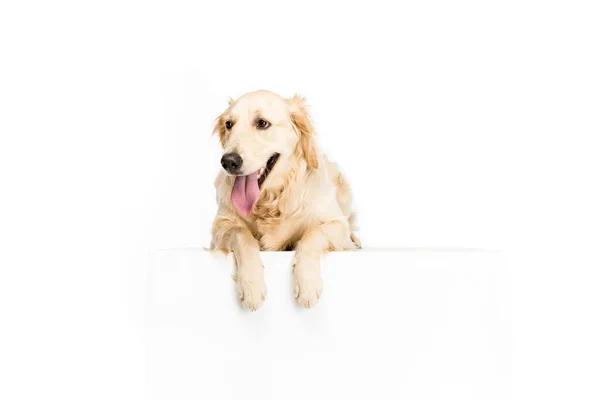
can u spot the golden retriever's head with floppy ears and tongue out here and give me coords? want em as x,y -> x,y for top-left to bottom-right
215,90 -> 319,216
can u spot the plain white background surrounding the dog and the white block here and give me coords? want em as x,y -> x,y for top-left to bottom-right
0,1 -> 600,399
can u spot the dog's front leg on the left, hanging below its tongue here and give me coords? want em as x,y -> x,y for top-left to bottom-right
213,223 -> 267,311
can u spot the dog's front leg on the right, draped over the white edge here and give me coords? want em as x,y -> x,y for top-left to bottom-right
293,219 -> 349,308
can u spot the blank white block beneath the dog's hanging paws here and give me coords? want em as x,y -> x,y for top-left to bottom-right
147,249 -> 511,400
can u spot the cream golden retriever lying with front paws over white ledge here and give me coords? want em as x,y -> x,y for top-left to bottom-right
210,90 -> 360,311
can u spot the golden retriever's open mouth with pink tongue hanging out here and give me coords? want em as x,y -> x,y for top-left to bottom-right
231,153 -> 279,217
